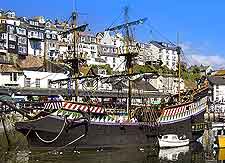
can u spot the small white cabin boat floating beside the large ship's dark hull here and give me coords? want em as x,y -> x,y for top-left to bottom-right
158,134 -> 189,148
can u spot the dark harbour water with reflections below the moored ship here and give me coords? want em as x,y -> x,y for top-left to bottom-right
0,133 -> 222,163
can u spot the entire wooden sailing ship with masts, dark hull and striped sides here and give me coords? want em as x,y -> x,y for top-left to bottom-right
11,9 -> 207,148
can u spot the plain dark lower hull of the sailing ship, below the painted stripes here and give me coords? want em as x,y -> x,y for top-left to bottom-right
16,112 -> 204,148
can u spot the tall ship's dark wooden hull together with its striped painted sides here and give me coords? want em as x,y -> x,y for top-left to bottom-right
16,97 -> 207,148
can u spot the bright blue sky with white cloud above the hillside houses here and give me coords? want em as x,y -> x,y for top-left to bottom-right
0,0 -> 225,68
